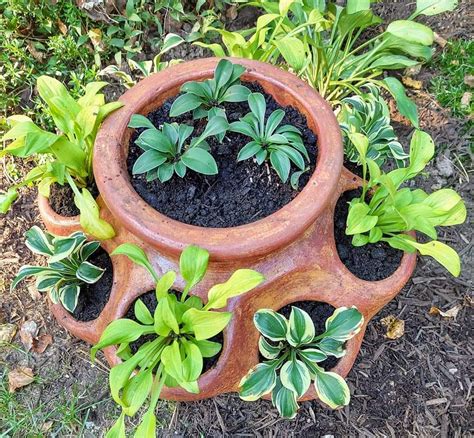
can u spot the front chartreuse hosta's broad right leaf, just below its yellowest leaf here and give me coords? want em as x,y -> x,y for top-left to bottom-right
182,309 -> 232,341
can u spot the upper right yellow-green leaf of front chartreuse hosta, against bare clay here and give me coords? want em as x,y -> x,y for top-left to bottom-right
205,269 -> 265,309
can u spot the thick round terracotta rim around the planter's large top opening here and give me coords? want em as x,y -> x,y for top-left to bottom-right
93,58 -> 343,261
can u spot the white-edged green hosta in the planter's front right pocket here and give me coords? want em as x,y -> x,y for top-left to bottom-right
240,307 -> 364,418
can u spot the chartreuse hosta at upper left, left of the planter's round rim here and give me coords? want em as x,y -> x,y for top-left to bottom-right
0,76 -> 123,239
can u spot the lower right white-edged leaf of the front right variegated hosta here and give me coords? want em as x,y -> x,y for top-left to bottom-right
314,367 -> 351,409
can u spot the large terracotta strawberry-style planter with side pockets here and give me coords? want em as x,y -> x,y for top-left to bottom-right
37,58 -> 416,400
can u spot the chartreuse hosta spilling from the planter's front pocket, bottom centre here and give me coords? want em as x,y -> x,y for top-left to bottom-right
92,244 -> 264,438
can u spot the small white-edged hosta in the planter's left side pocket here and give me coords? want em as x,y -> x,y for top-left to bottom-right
11,226 -> 104,312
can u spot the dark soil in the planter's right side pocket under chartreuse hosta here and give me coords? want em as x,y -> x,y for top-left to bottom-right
334,189 -> 403,281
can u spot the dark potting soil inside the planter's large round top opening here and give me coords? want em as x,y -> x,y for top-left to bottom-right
127,83 -> 317,228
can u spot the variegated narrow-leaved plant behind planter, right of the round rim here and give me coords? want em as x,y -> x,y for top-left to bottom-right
338,84 -> 408,166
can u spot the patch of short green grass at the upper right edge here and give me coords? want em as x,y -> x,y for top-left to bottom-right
430,40 -> 474,117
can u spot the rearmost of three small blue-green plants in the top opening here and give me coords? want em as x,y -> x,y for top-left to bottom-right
170,59 -> 250,119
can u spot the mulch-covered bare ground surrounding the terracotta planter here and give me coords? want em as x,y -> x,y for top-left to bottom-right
0,2 -> 474,437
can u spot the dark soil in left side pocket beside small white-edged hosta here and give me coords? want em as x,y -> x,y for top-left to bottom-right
72,248 -> 114,322
